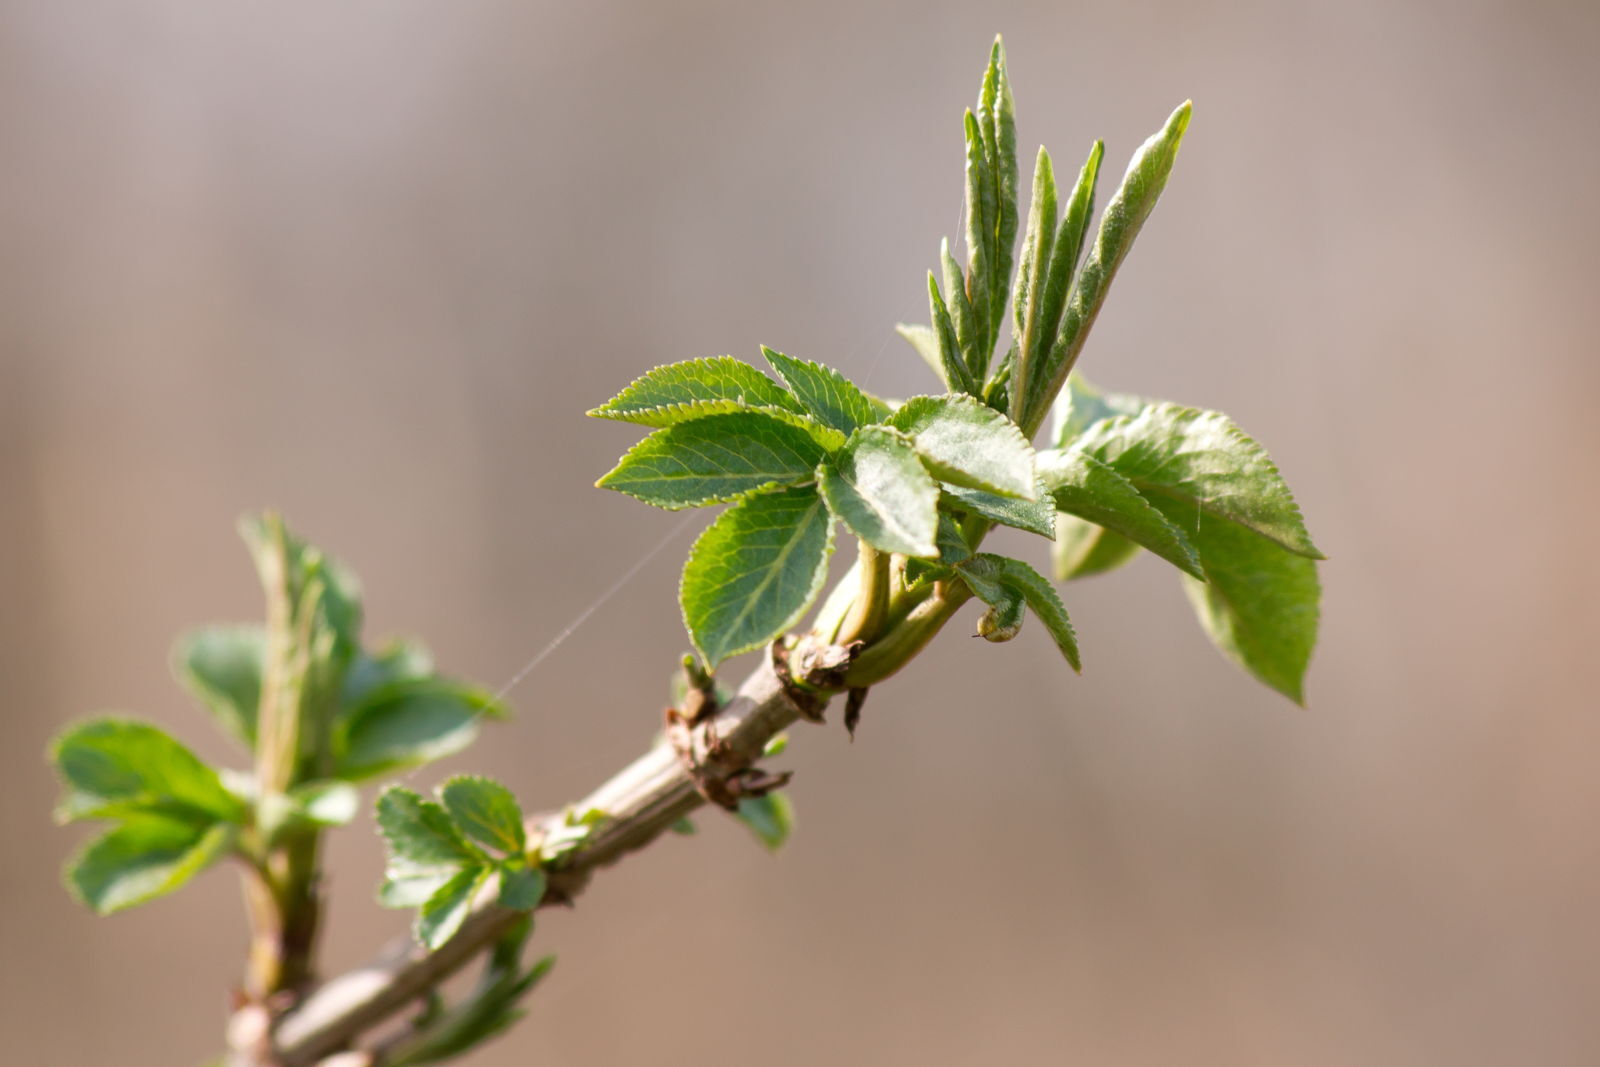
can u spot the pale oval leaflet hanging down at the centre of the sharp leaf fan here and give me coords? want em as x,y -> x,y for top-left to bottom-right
818,426 -> 939,555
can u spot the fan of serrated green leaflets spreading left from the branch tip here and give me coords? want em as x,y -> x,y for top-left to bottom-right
590,349 -> 1038,667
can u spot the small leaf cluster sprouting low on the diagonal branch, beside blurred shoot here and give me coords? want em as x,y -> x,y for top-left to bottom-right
378,776 -> 546,949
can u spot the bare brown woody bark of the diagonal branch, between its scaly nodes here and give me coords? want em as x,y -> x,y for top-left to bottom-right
274,643 -> 812,1067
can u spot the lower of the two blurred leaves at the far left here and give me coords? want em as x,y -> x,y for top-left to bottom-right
64,816 -> 235,915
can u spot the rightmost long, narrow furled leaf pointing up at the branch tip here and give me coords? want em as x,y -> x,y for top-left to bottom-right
1022,101 -> 1190,429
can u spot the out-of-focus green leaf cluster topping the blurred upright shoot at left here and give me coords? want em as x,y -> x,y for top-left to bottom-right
50,515 -> 502,915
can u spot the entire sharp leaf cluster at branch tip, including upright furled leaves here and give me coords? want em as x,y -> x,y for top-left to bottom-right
589,40 -> 1323,701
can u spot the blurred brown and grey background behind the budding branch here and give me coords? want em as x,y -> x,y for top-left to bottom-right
0,0 -> 1600,1067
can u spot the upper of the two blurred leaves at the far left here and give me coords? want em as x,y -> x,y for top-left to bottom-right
50,718 -> 245,824
